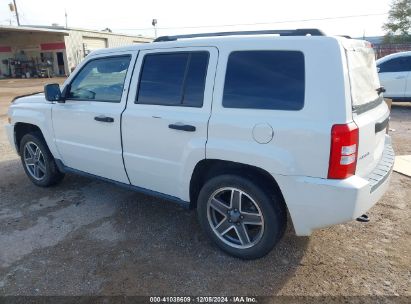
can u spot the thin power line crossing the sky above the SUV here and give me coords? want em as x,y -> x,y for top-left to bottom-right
115,13 -> 388,31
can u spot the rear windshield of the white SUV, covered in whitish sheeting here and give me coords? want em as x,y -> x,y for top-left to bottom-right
346,47 -> 380,109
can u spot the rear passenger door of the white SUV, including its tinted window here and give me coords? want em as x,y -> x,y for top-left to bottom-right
122,47 -> 218,200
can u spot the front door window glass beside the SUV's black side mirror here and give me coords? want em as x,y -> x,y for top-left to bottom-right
67,56 -> 131,102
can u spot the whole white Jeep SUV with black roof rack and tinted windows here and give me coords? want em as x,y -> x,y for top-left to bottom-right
6,29 -> 394,259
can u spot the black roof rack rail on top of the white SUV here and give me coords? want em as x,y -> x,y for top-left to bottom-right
153,29 -> 325,42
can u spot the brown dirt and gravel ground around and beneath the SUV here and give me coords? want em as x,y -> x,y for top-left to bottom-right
0,79 -> 411,297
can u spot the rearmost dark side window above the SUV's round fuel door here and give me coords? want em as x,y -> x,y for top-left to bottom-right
223,51 -> 305,110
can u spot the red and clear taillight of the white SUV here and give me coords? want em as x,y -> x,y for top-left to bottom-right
328,122 -> 358,179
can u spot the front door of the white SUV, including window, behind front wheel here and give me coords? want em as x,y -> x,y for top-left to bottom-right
52,53 -> 136,183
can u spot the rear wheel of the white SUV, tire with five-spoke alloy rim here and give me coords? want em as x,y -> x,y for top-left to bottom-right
197,175 -> 287,260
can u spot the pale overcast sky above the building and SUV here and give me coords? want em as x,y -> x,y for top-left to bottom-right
0,0 -> 391,37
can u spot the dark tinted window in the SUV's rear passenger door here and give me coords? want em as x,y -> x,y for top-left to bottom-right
136,52 -> 209,107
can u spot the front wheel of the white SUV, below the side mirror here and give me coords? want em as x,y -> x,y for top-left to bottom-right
20,132 -> 64,187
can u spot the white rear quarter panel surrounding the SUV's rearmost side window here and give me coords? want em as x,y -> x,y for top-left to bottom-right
206,37 -> 351,177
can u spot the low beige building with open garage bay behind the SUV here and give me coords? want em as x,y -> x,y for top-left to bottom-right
0,25 -> 152,78
